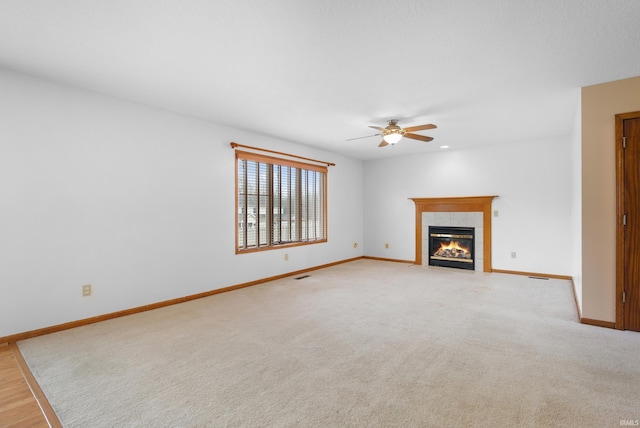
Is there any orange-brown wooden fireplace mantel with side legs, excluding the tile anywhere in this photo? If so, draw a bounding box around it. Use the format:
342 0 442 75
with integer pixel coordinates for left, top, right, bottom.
409 196 497 272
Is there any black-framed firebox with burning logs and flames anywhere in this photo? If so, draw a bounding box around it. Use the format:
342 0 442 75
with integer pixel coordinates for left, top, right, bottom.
429 226 475 270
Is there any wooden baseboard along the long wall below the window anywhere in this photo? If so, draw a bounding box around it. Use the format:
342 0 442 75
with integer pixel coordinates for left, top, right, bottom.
0 257 362 343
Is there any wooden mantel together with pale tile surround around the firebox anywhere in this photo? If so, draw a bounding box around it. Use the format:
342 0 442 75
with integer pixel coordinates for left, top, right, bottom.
410 196 497 272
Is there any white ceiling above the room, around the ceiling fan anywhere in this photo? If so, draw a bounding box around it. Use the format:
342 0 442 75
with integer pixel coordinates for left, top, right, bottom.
0 0 640 159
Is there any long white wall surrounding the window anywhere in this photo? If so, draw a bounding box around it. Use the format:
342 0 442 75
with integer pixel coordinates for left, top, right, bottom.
0 71 363 336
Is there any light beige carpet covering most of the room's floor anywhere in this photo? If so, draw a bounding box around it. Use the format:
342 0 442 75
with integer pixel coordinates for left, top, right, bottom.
18 260 640 427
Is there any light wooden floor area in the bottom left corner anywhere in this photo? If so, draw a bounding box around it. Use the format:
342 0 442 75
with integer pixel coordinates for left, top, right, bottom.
0 343 62 428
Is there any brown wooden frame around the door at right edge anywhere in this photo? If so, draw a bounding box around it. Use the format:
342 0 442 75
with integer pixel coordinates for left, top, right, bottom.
615 111 640 330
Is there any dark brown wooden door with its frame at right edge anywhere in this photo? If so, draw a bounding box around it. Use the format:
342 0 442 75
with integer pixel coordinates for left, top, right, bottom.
616 112 640 331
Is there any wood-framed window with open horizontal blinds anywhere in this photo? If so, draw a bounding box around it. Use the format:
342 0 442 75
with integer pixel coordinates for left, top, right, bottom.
236 150 327 253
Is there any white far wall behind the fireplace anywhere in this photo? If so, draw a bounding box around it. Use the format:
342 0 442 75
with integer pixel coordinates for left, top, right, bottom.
364 136 572 275
